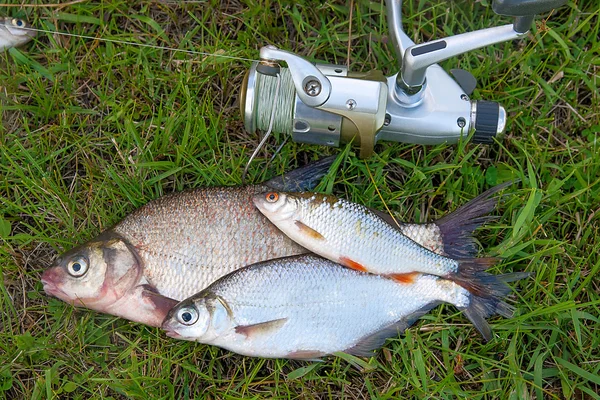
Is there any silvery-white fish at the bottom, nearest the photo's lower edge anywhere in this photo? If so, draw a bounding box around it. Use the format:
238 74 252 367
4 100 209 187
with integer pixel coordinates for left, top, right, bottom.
162 254 521 360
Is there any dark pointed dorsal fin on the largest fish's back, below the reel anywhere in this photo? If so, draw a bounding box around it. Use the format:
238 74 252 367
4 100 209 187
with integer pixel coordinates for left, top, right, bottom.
266 156 337 192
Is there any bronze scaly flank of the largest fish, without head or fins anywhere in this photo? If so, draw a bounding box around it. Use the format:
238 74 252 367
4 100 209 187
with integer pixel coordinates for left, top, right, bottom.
113 185 306 299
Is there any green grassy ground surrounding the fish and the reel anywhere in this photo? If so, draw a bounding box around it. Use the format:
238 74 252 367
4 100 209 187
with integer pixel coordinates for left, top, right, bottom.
0 0 600 399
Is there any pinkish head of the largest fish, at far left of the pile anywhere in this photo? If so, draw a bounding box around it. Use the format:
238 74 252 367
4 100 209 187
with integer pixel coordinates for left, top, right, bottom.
41 233 141 312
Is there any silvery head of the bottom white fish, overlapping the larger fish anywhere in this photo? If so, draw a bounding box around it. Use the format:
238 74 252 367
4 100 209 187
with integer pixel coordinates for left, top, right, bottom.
162 292 233 343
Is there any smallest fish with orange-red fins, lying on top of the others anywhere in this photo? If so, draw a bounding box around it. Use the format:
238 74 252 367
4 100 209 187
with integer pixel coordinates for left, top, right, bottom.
253 182 516 291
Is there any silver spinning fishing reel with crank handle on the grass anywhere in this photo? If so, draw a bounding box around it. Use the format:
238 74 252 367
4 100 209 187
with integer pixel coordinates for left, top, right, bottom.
240 0 566 158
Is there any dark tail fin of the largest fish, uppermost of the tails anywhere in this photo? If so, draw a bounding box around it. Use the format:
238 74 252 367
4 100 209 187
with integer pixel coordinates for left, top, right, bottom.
435 181 513 259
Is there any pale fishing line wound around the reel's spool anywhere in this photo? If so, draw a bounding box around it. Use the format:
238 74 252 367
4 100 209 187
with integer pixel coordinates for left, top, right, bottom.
254 68 296 135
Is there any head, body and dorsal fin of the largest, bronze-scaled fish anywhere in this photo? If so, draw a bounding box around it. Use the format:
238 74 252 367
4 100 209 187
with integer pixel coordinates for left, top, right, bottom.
41 157 335 327
